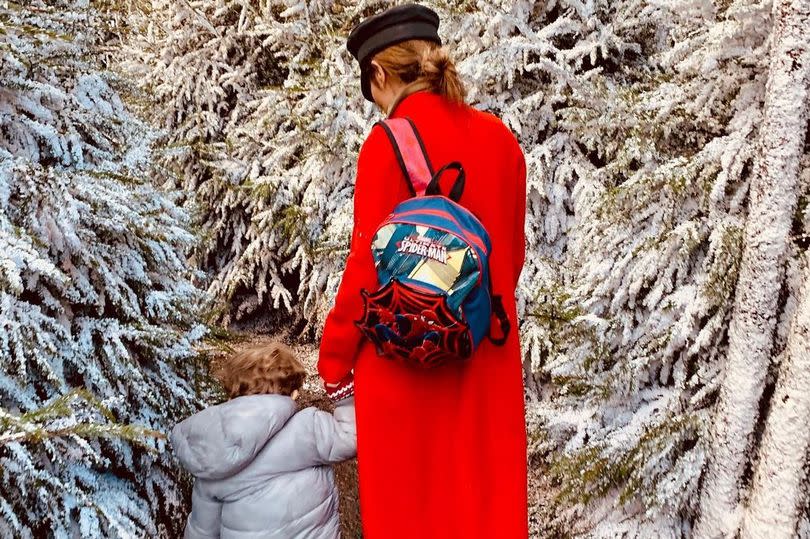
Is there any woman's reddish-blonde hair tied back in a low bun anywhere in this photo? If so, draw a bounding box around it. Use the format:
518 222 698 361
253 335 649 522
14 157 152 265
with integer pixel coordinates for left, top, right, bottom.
374 39 467 114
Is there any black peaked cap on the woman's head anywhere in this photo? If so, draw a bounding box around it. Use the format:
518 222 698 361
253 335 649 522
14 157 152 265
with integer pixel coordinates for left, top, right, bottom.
346 4 442 101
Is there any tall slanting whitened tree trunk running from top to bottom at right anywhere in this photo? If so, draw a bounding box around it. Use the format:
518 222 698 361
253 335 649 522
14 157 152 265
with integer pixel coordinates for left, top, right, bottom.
695 0 810 538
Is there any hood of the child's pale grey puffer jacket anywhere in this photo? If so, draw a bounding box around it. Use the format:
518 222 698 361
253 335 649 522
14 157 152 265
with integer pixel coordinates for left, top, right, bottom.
172 395 296 479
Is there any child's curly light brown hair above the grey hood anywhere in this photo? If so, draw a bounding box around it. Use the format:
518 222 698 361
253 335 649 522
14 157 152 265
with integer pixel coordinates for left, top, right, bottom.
214 342 307 399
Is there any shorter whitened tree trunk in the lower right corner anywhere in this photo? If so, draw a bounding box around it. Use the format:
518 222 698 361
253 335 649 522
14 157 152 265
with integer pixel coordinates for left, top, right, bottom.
742 256 810 539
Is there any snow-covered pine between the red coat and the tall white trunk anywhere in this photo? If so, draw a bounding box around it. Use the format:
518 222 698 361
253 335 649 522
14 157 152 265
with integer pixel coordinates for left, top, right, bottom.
516 2 806 537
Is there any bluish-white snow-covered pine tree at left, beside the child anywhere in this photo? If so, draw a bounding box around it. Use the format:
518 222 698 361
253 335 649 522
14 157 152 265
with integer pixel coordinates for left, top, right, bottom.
0 0 204 538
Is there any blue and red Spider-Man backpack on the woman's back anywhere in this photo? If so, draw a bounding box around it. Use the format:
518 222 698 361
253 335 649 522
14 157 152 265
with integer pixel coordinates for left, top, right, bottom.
355 118 510 367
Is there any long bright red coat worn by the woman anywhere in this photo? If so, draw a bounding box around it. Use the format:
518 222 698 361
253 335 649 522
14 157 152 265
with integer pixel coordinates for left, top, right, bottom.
318 91 528 539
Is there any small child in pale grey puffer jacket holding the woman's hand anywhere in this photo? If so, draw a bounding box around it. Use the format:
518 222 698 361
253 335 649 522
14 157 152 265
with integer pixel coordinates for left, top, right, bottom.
171 343 356 539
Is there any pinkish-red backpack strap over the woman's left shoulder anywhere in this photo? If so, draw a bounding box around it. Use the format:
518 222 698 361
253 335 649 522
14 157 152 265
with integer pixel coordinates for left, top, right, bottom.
377 118 433 196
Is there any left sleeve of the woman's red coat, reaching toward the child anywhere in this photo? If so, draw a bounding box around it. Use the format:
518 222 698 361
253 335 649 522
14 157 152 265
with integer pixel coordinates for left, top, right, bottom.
318 127 404 383
